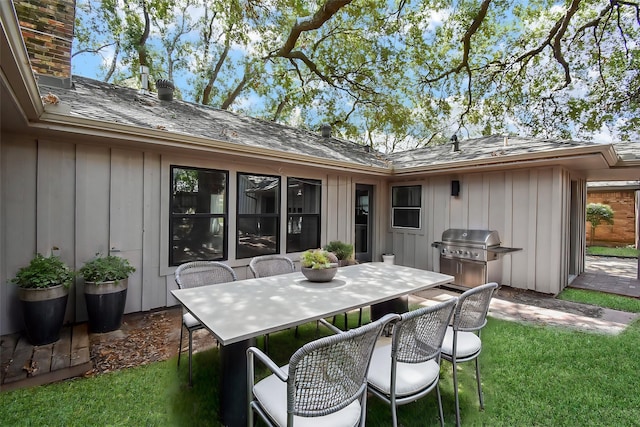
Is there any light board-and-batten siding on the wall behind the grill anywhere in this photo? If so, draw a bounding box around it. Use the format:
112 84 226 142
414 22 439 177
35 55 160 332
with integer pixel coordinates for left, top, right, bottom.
388 167 585 294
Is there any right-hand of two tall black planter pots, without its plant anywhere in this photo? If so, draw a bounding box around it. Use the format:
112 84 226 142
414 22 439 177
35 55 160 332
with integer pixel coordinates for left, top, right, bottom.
84 279 128 333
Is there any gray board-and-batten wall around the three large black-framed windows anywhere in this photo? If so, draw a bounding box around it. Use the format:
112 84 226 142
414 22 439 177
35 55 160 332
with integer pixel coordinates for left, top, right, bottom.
0 133 386 334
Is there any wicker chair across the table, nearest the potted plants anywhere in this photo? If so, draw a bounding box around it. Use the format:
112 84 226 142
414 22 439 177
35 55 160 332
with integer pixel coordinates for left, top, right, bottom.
174 261 238 386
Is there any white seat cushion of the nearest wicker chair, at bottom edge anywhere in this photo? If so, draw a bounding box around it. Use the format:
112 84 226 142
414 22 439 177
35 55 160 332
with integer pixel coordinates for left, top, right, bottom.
253 365 361 427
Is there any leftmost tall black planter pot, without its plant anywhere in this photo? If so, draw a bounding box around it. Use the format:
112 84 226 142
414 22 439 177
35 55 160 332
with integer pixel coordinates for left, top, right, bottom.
18 285 69 345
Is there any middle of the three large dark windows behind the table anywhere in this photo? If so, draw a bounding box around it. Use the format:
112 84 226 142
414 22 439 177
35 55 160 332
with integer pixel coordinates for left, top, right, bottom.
236 173 280 259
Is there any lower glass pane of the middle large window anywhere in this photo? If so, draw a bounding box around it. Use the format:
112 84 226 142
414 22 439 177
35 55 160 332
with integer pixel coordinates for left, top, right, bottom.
236 217 279 258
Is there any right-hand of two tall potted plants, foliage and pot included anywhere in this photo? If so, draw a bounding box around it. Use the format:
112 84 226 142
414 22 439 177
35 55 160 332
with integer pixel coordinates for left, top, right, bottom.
79 255 136 333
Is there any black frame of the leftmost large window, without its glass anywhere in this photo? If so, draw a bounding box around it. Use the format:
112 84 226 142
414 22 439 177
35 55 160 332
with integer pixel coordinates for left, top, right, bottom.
167 164 230 268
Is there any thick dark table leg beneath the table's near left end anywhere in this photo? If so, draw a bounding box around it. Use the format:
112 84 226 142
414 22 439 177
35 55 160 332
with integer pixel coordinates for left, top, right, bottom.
220 339 255 427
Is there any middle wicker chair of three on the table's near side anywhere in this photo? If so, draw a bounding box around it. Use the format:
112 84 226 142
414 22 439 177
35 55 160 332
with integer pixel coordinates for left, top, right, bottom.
367 298 458 427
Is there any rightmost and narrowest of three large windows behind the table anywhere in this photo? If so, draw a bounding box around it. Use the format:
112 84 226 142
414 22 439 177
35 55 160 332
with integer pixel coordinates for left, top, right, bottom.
287 178 322 253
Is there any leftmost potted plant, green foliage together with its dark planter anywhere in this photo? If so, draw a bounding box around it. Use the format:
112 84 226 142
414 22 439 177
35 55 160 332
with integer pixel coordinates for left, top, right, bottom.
11 253 74 345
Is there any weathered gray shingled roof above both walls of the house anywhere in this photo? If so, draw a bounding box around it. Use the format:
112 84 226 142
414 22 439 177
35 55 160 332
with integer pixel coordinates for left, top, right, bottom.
40 76 632 172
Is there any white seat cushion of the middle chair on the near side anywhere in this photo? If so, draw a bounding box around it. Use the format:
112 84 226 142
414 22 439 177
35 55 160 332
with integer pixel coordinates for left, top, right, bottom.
367 344 440 397
